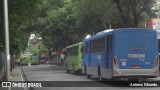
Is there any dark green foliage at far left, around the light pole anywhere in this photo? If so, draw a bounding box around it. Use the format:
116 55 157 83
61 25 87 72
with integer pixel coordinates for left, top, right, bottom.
0 0 40 54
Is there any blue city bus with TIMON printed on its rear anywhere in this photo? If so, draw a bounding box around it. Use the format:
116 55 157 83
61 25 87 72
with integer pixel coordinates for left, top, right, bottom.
82 28 159 80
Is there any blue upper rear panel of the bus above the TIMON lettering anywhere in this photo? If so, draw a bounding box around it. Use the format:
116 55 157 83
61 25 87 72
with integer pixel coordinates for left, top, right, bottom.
117 32 155 47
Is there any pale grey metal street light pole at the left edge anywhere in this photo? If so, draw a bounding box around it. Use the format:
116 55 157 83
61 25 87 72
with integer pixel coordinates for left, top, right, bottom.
3 0 10 81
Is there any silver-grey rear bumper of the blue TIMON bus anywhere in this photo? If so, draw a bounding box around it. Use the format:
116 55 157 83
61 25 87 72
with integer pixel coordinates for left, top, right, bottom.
113 66 159 78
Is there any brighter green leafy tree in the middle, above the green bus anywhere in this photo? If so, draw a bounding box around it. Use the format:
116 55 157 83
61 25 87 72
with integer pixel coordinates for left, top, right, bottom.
27 0 82 50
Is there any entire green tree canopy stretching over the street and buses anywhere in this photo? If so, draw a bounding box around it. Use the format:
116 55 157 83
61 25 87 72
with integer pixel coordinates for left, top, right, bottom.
0 0 159 53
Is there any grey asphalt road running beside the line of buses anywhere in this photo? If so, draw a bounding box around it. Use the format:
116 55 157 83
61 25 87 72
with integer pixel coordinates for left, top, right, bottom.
22 65 160 90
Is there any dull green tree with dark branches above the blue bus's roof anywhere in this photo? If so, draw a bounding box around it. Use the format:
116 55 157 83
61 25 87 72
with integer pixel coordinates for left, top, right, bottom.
75 0 156 33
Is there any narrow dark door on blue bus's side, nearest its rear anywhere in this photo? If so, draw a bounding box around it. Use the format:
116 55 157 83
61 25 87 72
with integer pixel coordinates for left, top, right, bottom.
106 35 113 68
